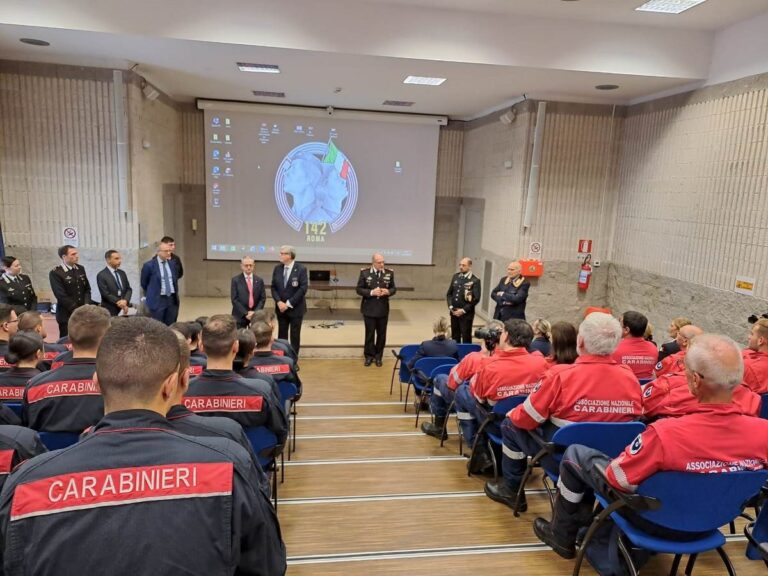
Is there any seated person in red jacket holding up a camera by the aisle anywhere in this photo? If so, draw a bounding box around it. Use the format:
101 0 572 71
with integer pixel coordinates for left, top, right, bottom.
421 320 504 440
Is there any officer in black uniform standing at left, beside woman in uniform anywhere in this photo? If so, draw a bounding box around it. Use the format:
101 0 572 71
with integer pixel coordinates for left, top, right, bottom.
48 244 91 336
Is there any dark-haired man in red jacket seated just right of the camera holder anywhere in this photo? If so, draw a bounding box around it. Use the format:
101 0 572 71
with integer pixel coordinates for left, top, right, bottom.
456 318 549 472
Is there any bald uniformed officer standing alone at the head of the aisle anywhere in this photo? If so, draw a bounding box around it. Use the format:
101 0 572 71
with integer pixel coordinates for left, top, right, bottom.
357 254 397 366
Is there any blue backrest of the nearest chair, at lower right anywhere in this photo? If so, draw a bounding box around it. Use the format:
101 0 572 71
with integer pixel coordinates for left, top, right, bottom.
637 470 768 532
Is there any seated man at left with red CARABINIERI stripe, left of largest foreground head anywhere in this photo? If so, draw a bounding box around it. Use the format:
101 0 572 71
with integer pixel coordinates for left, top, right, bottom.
22 304 111 434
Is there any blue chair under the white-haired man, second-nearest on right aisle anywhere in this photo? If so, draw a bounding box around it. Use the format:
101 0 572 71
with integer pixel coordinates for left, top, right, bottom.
514 422 645 516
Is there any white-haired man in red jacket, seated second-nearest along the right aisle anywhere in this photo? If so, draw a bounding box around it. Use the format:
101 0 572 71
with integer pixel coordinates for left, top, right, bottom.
485 312 642 512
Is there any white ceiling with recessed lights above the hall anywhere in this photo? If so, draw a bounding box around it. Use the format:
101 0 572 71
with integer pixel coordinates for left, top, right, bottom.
0 0 768 118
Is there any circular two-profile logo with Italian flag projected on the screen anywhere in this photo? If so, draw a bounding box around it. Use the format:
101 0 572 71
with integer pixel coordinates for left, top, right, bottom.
275 140 357 233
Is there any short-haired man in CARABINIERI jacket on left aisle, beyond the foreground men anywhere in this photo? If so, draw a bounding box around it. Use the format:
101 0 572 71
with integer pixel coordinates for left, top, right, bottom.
184 314 288 444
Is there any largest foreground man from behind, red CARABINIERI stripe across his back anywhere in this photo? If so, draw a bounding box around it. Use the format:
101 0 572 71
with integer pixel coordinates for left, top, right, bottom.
0 318 286 576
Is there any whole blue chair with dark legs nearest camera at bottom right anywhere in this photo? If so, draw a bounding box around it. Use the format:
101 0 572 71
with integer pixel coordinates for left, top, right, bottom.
573 470 768 576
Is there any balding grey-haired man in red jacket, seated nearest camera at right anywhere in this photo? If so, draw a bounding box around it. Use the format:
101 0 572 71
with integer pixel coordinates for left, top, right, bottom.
533 334 768 573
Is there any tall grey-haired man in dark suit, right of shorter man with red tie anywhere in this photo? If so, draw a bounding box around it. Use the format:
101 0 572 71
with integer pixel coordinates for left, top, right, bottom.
272 246 309 354
